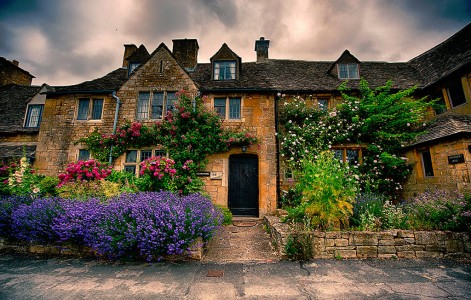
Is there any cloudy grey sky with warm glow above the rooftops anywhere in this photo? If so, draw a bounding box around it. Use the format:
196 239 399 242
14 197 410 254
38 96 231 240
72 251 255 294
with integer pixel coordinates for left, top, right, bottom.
0 0 471 85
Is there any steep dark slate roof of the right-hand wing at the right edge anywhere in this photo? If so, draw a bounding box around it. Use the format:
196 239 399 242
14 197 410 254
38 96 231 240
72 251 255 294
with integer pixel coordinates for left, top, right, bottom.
409 23 471 87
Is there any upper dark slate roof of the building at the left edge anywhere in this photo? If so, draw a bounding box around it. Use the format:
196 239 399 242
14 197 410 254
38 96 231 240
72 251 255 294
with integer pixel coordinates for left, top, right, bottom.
0 84 41 133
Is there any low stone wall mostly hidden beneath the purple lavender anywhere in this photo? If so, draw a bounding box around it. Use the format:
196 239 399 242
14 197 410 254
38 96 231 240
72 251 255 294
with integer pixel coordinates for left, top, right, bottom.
0 238 205 261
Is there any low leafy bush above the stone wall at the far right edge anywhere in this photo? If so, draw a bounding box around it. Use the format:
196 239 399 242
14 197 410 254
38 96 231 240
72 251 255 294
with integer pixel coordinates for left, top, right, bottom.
407 190 471 231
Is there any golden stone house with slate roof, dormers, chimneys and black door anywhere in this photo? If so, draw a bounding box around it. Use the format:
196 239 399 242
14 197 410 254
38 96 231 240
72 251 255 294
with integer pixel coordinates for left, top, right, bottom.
26 24 471 216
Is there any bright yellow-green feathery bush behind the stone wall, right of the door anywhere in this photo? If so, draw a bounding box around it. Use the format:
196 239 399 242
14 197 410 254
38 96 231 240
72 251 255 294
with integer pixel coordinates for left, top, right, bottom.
288 151 358 230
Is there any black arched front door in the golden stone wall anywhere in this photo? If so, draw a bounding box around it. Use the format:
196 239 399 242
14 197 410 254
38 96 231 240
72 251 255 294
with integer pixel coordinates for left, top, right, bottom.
229 155 258 216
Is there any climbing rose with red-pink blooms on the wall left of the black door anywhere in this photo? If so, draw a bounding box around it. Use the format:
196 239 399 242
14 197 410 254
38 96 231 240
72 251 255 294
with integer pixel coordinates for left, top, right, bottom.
79 91 257 194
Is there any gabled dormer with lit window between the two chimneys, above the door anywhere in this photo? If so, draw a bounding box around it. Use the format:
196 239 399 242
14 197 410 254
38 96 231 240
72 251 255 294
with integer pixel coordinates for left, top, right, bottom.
210 43 242 80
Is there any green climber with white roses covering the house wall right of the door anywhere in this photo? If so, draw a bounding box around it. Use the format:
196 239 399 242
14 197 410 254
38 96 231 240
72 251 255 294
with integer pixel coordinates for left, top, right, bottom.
280 80 433 196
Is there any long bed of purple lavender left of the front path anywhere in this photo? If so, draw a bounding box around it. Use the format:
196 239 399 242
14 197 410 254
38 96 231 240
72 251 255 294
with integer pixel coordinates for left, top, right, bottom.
0 192 222 261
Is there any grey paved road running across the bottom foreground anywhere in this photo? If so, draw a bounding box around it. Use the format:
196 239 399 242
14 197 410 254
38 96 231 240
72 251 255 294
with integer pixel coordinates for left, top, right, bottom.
0 254 471 300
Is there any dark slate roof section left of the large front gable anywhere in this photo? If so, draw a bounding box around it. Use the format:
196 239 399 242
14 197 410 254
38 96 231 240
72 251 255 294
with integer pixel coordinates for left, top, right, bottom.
47 68 127 95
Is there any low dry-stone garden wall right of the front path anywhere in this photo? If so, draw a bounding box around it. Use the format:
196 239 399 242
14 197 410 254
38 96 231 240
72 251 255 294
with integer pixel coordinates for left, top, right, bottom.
264 216 471 258
